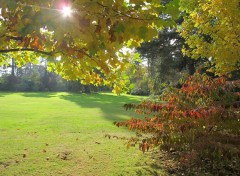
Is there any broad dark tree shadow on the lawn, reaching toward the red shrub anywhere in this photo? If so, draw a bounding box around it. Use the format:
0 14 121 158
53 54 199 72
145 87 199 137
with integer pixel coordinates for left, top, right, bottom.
60 93 142 122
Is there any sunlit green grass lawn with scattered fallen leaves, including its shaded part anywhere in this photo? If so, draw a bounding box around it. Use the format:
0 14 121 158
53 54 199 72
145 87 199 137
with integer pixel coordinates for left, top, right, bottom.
0 92 165 176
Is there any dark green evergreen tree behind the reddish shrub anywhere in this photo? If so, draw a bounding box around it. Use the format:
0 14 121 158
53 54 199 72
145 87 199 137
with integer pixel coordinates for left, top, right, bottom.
137 28 197 94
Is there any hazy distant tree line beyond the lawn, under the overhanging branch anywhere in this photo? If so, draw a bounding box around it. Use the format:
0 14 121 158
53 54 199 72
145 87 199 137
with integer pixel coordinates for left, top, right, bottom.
0 59 110 93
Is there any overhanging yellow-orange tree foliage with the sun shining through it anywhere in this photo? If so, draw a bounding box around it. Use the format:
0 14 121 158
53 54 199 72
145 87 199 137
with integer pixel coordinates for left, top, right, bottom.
0 0 178 93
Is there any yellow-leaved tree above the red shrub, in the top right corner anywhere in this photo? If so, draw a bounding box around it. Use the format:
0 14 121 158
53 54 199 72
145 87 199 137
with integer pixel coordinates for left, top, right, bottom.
179 0 240 75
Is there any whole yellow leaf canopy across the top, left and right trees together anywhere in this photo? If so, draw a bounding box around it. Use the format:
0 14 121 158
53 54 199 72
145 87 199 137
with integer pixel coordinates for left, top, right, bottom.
0 0 240 92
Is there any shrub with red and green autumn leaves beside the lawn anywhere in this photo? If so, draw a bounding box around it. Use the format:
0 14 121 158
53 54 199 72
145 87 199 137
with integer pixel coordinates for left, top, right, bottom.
116 74 240 152
